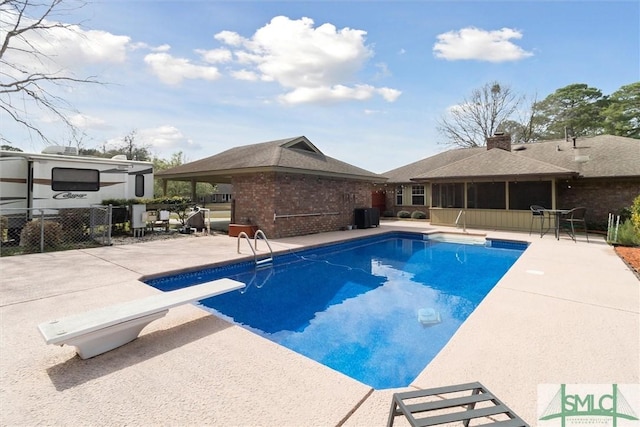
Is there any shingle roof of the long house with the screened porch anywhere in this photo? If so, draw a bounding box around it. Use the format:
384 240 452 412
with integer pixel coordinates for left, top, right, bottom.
383 135 640 182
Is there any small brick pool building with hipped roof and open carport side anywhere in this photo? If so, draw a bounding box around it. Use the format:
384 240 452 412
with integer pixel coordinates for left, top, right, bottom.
156 136 386 238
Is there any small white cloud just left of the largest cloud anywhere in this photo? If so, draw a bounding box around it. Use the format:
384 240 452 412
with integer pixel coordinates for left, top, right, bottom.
144 52 221 85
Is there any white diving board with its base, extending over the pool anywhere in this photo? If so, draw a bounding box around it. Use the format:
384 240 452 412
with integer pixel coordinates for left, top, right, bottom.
38 279 245 359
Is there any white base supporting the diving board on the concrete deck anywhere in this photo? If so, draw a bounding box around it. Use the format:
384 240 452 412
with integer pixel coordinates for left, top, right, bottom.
65 310 169 359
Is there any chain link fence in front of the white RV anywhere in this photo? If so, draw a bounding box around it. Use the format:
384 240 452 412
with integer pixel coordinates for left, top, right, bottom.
0 206 113 256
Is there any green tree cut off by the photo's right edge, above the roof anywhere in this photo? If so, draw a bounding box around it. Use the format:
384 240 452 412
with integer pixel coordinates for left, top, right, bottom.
602 82 640 139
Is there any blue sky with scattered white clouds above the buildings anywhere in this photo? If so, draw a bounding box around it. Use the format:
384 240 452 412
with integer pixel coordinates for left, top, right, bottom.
0 0 640 173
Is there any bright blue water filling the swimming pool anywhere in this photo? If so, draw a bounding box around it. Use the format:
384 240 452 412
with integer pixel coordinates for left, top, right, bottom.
147 233 526 389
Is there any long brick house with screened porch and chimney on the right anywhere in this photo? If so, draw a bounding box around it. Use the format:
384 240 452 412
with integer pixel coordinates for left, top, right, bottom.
382 135 640 230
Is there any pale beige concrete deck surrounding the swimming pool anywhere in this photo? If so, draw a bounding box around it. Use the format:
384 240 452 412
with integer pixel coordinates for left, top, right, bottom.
0 221 640 426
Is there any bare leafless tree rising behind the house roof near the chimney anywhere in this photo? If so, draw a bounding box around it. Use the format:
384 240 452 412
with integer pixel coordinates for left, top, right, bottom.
438 81 523 147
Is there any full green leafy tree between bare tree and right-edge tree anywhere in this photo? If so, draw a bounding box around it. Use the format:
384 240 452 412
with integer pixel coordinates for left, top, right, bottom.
535 83 608 139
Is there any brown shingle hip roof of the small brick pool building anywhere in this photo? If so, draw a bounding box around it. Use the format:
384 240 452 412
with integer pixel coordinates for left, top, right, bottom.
156 136 386 182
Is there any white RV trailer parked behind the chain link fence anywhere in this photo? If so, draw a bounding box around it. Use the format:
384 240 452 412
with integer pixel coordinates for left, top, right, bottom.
0 147 153 239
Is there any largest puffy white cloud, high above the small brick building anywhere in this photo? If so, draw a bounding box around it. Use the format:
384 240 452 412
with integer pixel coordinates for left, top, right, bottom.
215 16 400 104
